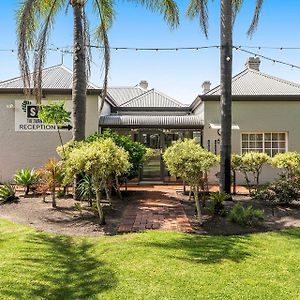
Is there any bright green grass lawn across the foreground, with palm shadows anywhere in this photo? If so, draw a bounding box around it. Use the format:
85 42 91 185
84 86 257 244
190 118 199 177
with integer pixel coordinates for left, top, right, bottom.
0 220 300 300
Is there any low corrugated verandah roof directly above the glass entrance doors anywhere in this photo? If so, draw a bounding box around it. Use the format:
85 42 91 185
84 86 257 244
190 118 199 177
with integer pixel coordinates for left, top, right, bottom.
99 115 204 128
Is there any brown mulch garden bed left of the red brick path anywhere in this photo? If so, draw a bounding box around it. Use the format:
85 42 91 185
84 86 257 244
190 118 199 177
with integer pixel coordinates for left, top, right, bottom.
0 196 126 236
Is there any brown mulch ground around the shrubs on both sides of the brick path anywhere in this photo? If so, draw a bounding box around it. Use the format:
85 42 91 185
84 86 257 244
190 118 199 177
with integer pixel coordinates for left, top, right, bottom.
0 186 300 236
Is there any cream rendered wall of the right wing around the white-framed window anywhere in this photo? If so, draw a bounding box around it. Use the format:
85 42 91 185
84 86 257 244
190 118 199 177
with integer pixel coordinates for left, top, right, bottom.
203 99 300 183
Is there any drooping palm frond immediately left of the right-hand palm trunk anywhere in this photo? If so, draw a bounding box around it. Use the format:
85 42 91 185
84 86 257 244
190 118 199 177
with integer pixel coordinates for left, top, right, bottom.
186 0 208 38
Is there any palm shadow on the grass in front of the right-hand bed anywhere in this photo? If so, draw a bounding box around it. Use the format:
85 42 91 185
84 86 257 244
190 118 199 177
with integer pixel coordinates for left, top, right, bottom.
140 234 252 264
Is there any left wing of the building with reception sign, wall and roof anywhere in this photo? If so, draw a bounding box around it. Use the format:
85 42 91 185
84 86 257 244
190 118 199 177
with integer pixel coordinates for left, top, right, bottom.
0 65 101 182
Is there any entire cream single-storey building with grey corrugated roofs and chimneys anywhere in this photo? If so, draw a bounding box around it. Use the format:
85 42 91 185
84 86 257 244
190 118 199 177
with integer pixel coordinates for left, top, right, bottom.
0 58 300 183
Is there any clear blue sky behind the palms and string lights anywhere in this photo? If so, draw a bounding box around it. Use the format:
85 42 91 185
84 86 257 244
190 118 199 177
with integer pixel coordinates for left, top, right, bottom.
0 0 300 103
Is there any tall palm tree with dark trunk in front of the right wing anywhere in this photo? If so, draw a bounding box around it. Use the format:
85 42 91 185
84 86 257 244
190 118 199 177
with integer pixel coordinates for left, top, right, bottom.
187 0 263 193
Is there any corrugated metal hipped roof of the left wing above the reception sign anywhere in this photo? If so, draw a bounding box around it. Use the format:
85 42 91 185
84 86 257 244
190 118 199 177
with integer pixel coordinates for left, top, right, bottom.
0 65 98 89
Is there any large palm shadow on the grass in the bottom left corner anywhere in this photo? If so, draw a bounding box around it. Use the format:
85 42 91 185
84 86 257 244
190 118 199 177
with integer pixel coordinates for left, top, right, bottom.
1 233 117 299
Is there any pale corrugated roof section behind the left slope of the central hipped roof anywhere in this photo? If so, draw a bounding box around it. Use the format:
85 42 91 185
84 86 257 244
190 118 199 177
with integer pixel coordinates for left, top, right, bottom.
108 86 147 106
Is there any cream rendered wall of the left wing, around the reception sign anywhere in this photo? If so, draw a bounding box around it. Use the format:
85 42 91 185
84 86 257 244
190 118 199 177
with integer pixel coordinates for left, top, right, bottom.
0 94 98 182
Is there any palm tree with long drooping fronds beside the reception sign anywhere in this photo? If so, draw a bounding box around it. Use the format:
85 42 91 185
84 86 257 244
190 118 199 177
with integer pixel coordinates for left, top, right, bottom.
17 0 179 141
